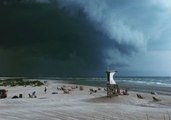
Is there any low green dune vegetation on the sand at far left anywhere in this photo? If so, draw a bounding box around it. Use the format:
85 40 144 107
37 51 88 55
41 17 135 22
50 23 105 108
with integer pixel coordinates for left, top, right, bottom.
0 79 44 87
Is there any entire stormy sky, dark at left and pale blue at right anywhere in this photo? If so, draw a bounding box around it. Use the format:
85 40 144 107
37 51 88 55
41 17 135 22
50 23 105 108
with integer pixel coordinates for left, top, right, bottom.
0 0 171 76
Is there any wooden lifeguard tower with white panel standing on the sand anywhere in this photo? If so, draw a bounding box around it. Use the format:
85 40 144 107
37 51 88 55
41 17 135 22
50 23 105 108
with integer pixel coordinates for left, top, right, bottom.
106 71 120 97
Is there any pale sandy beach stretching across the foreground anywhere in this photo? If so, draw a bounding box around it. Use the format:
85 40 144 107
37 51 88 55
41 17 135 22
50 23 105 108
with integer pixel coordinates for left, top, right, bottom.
0 81 171 120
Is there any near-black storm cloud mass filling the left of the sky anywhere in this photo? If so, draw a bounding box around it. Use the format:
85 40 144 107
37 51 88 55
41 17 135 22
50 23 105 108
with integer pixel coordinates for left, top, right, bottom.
0 0 111 76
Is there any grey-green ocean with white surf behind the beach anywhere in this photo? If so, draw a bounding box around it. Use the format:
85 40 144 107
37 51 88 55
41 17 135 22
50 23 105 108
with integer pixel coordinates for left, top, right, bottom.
0 76 171 95
